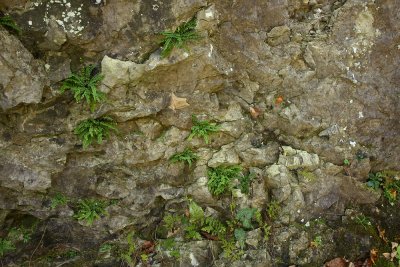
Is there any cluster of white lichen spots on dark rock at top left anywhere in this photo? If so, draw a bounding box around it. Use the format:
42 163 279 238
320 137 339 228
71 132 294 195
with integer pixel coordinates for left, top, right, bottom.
43 0 86 35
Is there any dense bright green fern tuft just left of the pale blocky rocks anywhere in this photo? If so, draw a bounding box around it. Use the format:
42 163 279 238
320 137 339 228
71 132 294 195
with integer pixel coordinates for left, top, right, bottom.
207 165 242 196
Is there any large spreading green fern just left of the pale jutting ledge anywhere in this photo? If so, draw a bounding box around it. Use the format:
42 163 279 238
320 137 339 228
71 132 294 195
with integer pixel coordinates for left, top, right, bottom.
60 65 105 112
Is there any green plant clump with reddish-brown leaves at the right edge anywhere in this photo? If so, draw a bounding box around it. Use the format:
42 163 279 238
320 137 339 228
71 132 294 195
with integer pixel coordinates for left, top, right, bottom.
367 170 400 205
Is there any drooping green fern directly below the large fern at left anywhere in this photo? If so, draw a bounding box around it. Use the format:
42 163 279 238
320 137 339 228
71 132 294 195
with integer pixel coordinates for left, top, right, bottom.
74 117 118 148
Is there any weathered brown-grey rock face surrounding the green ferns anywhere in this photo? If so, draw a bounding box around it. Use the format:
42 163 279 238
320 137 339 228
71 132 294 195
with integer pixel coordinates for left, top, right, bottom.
0 0 400 266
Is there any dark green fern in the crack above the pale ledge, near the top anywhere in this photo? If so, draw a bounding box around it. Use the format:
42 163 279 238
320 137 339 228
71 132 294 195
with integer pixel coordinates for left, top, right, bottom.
161 18 200 58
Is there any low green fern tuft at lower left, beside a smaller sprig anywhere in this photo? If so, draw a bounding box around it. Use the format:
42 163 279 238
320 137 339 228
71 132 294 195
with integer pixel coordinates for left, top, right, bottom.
75 199 108 226
